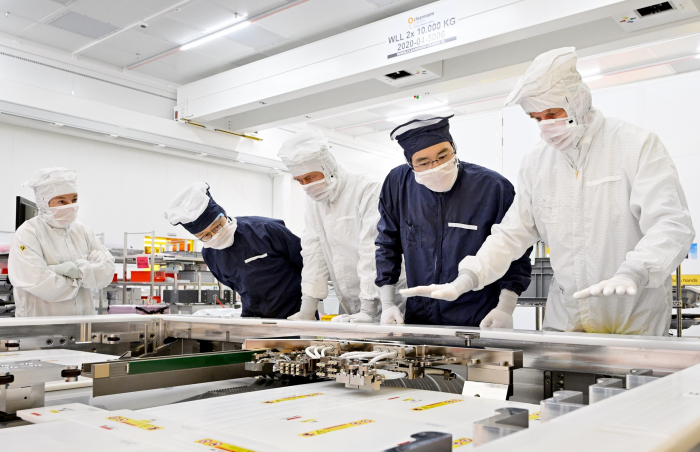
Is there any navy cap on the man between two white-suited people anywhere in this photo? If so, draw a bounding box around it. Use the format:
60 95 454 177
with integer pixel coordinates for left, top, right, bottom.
391 115 454 162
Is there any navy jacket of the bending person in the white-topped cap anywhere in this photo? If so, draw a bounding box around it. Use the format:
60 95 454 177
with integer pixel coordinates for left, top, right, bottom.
202 217 304 319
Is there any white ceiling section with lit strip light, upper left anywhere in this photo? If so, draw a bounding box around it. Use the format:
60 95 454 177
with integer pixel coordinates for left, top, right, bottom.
0 0 434 84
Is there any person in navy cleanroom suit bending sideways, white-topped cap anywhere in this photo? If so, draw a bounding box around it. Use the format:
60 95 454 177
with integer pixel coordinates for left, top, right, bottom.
166 182 303 319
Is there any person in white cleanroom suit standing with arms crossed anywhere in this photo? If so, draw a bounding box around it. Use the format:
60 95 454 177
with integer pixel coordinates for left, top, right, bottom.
8 168 115 317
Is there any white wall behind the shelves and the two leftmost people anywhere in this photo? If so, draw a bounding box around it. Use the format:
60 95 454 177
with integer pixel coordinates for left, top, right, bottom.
0 122 272 247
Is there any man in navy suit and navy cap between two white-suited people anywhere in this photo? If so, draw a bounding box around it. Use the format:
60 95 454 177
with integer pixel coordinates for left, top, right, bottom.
375 117 532 328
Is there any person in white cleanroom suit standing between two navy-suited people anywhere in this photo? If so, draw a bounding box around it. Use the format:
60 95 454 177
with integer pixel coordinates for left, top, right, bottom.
279 130 405 323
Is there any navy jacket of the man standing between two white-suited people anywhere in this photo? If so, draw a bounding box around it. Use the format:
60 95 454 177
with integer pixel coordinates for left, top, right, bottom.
376 162 532 326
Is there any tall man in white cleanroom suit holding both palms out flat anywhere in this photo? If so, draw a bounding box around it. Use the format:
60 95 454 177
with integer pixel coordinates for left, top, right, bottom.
400 47 695 336
